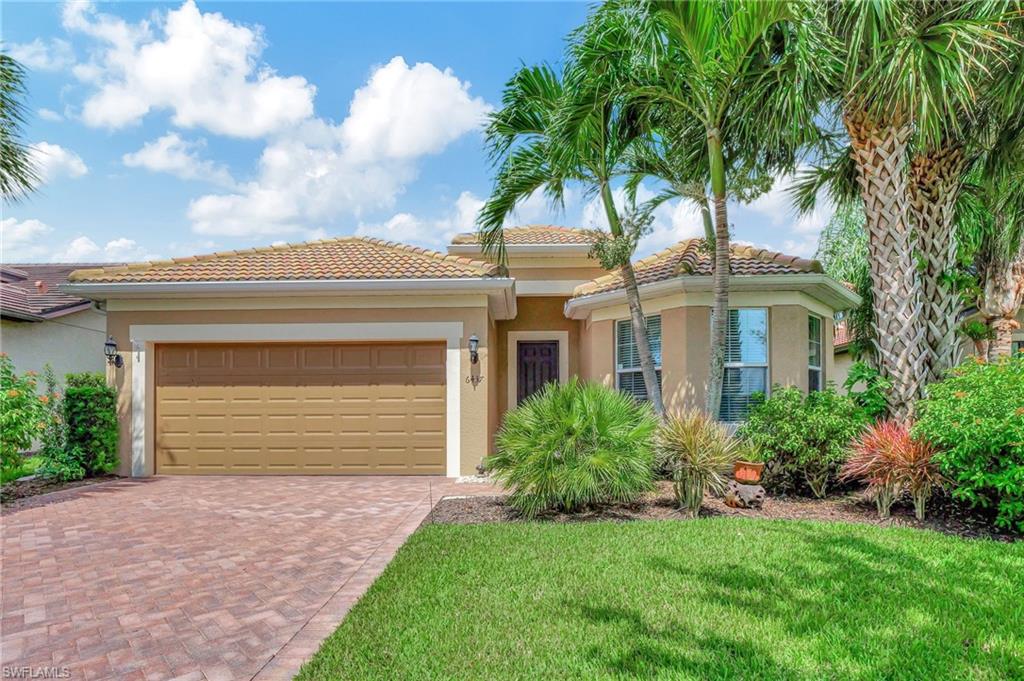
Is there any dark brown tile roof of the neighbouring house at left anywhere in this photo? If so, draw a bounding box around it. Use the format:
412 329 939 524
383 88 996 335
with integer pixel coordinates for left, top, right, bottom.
0 263 117 318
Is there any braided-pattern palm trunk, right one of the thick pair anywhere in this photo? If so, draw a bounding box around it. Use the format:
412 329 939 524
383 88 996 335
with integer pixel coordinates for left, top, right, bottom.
910 146 967 387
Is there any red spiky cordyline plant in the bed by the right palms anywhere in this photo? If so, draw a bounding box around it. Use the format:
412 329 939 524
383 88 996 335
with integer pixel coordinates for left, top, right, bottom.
840 421 944 520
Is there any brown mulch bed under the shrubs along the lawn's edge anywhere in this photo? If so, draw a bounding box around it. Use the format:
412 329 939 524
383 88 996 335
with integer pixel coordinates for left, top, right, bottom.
426 483 1024 542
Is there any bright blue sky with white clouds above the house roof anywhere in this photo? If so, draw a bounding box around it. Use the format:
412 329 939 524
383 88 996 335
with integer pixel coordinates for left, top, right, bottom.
0 0 830 263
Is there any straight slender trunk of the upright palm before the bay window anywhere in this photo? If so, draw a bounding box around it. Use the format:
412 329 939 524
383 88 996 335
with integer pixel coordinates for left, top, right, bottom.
705 128 731 419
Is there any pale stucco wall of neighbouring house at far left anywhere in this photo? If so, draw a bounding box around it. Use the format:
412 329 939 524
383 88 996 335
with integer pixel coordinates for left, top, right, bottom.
0 309 106 381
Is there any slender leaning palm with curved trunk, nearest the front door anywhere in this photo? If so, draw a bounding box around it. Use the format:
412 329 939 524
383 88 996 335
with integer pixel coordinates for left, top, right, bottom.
477 63 665 416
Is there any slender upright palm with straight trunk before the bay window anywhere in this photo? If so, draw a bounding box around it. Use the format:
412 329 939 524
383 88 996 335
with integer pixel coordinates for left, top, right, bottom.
579 0 831 415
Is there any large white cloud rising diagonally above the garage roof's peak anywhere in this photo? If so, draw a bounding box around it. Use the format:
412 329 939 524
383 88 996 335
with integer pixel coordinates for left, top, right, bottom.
188 57 488 236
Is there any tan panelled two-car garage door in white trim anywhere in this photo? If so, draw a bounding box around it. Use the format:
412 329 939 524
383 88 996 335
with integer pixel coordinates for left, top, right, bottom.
155 343 445 475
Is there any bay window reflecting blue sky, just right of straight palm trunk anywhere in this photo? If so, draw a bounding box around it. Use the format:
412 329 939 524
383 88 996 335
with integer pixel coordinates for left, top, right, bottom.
718 308 768 423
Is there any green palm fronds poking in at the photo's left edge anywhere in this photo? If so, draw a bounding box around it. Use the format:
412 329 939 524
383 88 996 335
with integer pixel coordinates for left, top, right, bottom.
0 52 39 201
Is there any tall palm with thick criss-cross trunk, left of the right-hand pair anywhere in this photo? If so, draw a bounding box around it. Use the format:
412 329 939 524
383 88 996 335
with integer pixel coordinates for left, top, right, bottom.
820 0 1006 419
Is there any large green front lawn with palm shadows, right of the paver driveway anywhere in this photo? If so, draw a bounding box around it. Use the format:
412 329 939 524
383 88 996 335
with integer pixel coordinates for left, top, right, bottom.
298 518 1024 679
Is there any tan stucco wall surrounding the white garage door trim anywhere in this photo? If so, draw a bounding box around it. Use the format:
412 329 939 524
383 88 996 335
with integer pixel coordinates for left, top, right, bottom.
100 301 494 475
